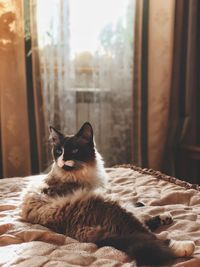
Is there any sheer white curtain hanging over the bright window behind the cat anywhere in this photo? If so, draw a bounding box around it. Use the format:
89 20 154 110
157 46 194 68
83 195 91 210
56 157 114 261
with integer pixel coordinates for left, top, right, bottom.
31 0 135 165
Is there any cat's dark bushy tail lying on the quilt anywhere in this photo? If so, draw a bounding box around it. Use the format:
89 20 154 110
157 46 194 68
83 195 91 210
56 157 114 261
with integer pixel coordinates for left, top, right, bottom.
96 233 176 266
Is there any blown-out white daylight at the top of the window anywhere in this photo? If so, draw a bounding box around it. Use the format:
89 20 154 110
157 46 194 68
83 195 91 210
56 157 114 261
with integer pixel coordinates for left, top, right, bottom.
37 0 130 56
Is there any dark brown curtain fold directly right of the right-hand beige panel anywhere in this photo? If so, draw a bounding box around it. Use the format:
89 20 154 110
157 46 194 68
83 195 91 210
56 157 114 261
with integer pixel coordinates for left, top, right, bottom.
163 1 190 175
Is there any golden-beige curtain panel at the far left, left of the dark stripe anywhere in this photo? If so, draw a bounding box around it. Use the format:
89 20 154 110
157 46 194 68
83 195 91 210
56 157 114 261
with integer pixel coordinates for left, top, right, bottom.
0 0 31 177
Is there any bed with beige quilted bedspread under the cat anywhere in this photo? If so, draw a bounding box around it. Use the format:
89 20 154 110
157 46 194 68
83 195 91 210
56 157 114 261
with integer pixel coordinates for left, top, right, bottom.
0 165 200 267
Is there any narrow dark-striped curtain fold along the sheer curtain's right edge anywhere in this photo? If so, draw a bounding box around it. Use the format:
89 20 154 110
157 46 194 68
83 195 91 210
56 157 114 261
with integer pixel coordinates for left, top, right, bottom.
132 0 149 167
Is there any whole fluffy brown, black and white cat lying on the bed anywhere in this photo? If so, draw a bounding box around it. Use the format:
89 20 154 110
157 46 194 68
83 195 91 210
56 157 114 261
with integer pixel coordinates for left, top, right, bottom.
21 122 194 266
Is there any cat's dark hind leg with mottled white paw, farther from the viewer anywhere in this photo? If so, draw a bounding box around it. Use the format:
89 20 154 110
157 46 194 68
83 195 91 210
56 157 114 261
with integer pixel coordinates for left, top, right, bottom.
144 212 173 232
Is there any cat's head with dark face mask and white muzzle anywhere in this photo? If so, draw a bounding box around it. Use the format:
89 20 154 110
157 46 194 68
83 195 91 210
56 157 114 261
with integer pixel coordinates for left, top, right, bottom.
49 122 95 171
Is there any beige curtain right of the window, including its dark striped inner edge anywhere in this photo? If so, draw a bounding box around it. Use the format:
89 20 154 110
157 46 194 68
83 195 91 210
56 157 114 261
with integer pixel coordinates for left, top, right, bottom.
133 0 175 169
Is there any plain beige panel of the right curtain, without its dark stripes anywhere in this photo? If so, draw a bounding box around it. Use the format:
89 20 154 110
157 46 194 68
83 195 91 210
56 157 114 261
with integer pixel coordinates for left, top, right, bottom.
147 0 176 170
